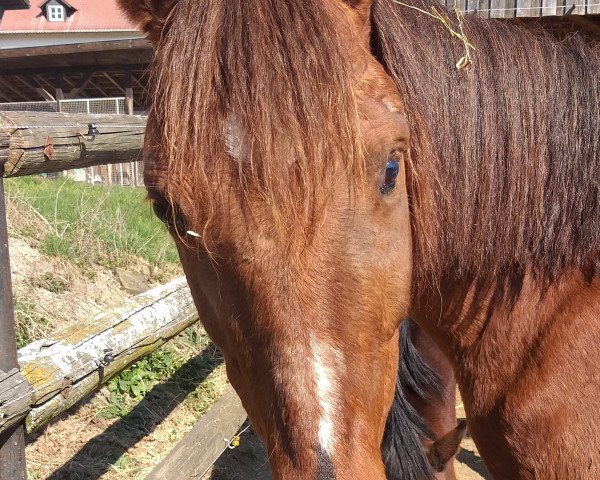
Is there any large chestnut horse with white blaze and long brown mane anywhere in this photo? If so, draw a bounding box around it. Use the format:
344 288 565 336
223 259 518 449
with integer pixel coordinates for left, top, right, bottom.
121 0 600 479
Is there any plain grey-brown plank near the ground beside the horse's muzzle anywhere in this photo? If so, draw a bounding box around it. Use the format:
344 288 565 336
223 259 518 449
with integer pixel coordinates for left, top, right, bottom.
146 387 246 480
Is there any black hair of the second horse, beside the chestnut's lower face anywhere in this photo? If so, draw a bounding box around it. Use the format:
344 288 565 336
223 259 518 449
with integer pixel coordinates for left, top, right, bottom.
381 319 442 480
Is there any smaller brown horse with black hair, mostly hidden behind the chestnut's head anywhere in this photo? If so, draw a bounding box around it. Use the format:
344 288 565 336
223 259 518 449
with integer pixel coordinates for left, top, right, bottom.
382 320 466 480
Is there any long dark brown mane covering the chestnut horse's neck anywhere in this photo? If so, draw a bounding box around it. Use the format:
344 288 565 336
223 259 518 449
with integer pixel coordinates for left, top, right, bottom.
373 0 600 282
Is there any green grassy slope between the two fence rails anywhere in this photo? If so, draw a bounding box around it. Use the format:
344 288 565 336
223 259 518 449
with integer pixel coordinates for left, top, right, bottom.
6 177 178 268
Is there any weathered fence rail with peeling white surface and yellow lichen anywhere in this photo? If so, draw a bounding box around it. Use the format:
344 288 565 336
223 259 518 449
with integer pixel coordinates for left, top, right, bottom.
0 278 198 433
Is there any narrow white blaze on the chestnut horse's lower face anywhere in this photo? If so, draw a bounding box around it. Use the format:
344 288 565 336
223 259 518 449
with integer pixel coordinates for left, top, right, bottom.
310 338 342 455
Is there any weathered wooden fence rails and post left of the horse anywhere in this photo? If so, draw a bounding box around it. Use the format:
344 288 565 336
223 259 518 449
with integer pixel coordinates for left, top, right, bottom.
0 112 246 480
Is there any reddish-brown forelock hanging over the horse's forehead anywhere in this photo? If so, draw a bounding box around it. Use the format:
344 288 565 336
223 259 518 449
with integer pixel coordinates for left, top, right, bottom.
152 0 362 240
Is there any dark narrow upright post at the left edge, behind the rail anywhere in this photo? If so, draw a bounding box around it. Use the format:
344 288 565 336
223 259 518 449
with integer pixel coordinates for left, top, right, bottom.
0 165 27 480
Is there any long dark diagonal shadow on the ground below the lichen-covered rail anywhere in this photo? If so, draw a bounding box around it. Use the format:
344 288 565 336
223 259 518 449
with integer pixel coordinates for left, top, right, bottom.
47 345 223 480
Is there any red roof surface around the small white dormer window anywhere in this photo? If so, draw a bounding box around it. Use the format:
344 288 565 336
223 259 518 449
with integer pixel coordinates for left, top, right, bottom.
0 0 137 34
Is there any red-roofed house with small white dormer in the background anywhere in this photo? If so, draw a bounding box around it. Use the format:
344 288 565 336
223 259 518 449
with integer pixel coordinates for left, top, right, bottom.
0 0 142 49
